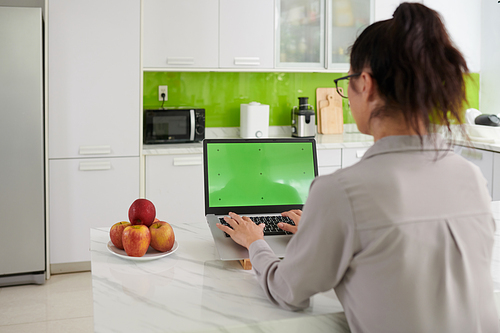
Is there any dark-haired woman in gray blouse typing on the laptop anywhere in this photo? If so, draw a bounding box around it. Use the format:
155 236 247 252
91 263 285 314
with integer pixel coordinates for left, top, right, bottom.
219 3 499 333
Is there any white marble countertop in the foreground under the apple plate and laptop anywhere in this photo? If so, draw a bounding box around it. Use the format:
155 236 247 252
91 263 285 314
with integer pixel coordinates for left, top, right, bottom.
90 201 500 333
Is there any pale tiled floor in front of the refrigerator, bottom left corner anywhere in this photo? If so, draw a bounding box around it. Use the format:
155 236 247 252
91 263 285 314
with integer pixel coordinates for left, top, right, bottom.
0 272 94 333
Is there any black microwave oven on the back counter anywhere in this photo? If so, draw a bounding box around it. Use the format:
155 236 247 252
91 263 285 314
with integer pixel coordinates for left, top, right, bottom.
143 107 205 144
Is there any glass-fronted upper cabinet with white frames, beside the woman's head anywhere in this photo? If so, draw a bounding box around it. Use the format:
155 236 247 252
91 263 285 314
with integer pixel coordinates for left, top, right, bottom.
276 0 373 72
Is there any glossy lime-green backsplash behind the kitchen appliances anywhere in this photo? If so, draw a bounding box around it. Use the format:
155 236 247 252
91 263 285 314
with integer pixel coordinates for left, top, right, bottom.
143 72 479 127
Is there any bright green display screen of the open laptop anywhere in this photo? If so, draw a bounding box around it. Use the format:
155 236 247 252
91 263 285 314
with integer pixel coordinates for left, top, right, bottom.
206 142 315 207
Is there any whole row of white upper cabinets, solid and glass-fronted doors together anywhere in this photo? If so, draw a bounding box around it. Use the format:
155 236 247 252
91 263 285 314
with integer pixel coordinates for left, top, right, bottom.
143 0 374 71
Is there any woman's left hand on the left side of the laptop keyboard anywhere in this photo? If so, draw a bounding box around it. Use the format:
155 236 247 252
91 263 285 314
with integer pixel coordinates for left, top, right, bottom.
217 212 265 249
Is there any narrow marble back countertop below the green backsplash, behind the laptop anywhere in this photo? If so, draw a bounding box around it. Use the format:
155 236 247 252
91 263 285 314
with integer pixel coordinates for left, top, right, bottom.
142 126 373 155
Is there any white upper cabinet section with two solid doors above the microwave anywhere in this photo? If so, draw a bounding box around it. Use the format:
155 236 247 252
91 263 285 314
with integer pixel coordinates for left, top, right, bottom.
143 0 274 69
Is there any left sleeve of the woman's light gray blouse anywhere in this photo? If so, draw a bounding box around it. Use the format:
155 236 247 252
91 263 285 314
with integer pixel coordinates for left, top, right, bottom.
249 176 355 310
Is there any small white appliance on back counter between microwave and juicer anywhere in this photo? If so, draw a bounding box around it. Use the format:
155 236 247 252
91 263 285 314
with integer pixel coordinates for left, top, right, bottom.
240 102 269 139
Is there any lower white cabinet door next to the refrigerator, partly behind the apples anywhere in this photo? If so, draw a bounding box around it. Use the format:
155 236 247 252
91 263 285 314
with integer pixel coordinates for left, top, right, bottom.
49 157 139 264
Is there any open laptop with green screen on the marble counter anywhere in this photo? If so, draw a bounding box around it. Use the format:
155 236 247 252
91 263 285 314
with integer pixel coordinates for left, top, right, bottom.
203 138 318 260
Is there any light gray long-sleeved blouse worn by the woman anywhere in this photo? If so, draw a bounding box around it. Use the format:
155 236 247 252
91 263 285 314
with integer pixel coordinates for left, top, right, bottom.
249 136 499 333
